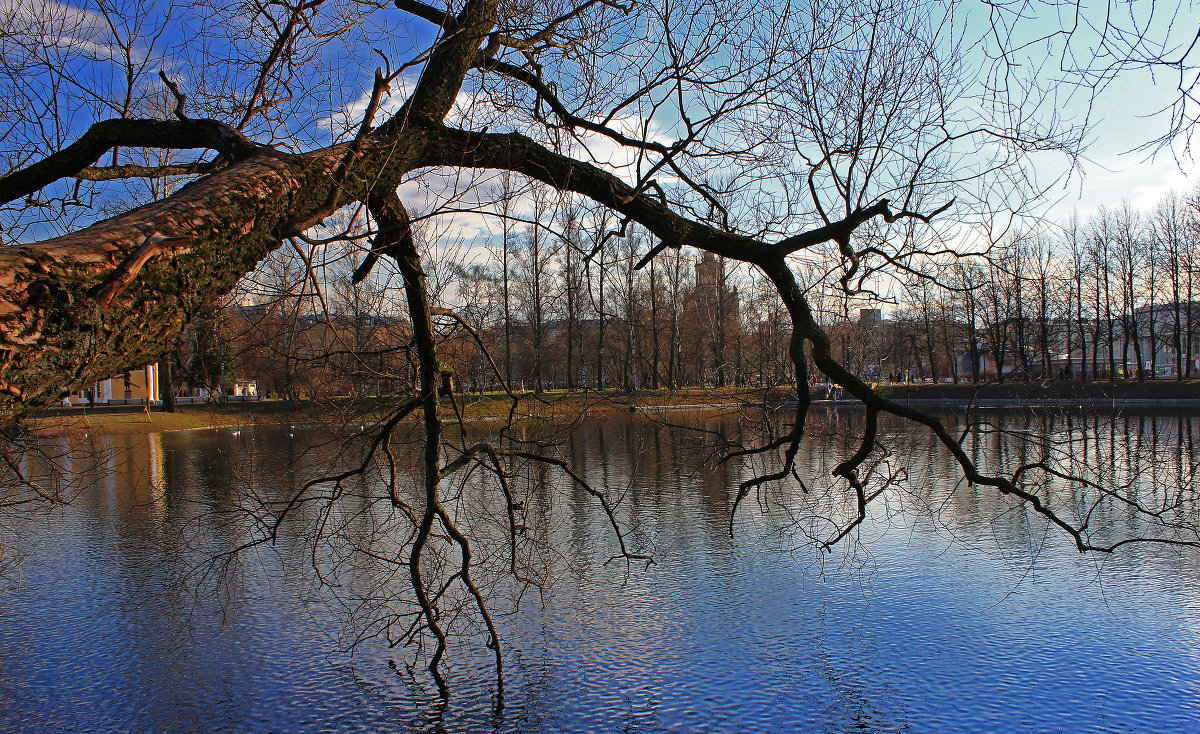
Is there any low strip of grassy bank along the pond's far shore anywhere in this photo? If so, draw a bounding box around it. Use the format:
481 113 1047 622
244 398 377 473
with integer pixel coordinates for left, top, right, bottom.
25 380 1200 434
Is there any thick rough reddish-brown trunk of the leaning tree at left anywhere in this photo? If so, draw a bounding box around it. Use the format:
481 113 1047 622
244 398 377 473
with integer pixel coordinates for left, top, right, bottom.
0 154 336 417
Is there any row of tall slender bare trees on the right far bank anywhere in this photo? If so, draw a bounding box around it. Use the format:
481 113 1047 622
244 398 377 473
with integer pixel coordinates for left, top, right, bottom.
866 193 1200 381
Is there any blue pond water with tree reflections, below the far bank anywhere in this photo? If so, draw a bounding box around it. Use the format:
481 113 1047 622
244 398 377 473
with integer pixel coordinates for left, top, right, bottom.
0 415 1200 732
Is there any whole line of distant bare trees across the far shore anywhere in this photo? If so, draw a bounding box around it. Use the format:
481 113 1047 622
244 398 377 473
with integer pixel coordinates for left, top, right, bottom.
170 183 1200 398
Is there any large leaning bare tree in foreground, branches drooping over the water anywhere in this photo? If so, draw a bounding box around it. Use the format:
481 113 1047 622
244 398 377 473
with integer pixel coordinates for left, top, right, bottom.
0 0 1196 687
